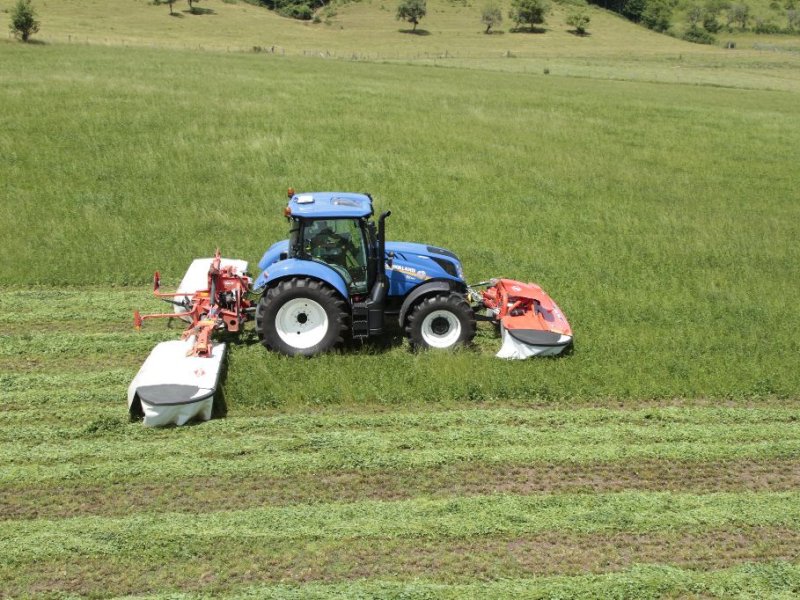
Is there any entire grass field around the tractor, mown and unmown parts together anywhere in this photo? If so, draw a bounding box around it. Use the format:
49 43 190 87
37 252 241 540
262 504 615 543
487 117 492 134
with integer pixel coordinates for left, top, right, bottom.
0 1 800 598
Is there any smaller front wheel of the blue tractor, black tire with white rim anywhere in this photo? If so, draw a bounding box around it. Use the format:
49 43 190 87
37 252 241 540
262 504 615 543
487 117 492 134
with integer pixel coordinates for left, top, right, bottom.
406 294 475 350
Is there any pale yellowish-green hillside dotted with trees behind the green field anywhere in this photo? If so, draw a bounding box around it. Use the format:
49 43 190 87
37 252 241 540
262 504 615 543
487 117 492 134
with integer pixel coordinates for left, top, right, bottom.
0 0 800 89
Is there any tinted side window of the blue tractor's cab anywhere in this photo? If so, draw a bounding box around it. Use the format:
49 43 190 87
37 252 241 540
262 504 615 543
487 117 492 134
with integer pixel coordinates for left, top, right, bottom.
303 219 367 294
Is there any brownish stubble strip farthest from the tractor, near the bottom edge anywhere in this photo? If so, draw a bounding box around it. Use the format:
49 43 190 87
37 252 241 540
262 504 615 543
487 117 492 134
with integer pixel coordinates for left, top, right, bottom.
0 527 800 597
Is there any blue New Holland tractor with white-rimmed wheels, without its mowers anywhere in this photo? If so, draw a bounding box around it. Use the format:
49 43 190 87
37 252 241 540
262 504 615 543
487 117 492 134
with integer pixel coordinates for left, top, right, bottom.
253 190 476 356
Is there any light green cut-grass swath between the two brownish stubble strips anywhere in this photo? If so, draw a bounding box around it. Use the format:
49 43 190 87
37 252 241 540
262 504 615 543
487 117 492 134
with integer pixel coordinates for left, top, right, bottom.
0 492 800 569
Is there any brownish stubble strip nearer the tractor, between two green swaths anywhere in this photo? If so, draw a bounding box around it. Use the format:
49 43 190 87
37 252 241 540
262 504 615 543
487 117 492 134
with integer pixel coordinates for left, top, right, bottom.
0 459 800 520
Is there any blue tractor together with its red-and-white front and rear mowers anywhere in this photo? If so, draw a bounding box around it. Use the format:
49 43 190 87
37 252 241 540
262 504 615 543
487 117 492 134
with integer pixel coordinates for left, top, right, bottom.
128 190 572 425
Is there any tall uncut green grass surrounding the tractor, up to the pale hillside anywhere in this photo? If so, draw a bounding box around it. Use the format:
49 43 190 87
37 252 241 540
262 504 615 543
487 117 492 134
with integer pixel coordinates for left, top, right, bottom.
0 45 800 407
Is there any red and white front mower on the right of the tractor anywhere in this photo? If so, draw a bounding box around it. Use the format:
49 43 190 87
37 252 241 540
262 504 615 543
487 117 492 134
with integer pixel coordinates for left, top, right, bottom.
483 279 572 359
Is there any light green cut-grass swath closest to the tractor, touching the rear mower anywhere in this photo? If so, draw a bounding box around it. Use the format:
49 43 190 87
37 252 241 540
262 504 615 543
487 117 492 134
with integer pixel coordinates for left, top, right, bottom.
0 398 800 484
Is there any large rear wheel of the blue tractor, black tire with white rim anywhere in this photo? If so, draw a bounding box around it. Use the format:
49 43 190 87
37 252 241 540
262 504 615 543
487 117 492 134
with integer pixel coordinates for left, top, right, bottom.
256 277 348 356
